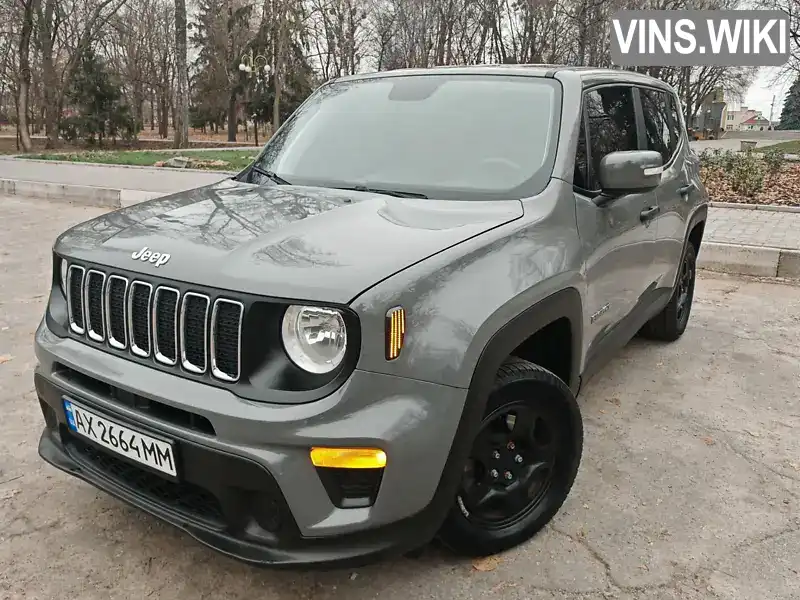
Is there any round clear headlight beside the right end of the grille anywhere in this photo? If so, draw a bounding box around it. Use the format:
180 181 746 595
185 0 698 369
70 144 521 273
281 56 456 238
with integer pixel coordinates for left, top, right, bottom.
281 305 347 374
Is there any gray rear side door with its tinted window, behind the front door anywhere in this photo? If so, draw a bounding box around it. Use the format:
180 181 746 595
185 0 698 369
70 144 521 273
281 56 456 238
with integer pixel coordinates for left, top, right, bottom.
639 87 693 287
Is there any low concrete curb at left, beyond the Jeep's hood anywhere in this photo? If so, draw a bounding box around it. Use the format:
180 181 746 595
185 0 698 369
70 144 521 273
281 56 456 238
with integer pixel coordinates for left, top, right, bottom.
0 179 167 208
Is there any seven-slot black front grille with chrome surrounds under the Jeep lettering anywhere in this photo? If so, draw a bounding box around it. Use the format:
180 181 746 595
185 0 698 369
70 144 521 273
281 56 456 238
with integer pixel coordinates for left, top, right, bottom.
66 265 244 383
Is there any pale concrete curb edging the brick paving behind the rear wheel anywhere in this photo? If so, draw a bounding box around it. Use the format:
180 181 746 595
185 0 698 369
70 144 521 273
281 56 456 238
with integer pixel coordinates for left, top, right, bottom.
697 242 800 279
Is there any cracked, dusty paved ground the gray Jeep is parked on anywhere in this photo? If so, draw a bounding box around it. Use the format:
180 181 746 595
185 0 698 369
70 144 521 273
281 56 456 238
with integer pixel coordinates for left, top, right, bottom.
0 197 800 600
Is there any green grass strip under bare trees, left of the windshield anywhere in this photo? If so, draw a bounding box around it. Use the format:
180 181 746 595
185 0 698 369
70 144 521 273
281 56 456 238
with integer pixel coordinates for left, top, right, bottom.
25 150 257 171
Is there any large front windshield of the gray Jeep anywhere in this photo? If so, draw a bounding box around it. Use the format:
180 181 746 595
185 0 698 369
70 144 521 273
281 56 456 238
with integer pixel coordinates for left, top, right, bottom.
256 75 561 200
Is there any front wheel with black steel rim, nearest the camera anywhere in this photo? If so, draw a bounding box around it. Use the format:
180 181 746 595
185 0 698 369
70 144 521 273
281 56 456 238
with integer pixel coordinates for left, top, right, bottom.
439 357 583 557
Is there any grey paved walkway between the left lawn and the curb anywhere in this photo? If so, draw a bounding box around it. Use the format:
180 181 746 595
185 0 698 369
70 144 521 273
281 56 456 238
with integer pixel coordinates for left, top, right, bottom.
0 158 228 194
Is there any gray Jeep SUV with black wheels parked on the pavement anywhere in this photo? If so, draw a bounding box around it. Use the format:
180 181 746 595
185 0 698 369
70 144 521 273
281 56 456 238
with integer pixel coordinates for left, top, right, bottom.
35 65 707 565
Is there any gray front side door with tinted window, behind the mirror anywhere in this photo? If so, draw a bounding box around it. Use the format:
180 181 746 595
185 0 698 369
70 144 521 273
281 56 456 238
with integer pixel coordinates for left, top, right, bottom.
575 85 658 356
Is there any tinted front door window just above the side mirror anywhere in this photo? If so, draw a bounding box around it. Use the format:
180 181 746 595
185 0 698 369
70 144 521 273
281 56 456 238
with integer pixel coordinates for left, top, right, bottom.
584 87 638 189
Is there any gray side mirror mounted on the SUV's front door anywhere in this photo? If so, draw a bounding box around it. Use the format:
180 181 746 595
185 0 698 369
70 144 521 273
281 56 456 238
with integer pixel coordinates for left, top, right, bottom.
598 150 664 204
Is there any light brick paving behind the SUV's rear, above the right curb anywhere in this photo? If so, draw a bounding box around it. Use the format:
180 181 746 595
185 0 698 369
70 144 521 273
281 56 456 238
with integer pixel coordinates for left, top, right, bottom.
704 206 800 250
